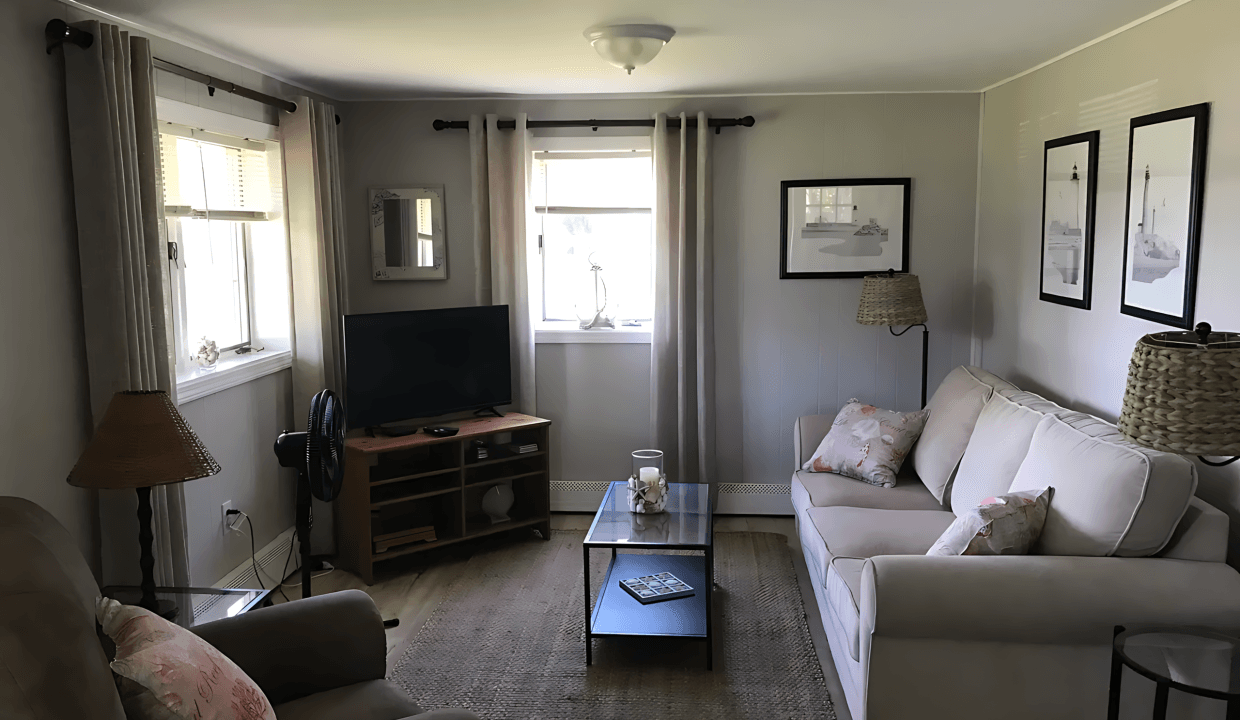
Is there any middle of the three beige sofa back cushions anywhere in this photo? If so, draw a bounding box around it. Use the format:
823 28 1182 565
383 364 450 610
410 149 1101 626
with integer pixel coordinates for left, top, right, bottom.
951 393 1043 517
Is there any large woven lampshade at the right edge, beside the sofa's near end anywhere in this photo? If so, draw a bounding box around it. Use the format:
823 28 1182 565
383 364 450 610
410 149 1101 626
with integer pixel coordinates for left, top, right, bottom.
1118 322 1240 467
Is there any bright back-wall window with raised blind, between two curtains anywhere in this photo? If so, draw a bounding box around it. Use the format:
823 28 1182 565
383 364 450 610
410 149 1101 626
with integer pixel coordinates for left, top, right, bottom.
532 138 653 325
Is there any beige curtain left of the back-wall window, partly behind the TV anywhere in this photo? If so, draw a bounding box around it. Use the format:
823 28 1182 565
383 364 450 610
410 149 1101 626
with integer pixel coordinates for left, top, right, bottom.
469 113 538 415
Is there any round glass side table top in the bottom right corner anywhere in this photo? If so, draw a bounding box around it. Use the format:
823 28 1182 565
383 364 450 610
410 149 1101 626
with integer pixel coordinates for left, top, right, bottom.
1115 628 1240 699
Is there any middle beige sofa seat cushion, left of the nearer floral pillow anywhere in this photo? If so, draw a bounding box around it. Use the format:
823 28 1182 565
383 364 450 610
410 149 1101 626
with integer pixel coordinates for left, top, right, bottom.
806 507 956 565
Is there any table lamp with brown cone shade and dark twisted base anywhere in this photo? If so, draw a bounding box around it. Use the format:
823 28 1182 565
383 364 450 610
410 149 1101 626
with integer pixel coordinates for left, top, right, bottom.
68 390 219 617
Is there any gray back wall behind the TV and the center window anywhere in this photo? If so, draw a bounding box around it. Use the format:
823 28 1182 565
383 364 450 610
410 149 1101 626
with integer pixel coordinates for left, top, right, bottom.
341 94 978 483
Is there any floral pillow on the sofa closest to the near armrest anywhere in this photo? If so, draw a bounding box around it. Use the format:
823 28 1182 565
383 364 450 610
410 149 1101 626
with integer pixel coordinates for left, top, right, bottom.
926 487 1054 555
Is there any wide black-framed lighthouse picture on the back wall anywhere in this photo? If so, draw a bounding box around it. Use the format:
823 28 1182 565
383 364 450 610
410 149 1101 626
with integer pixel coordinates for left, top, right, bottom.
779 177 913 279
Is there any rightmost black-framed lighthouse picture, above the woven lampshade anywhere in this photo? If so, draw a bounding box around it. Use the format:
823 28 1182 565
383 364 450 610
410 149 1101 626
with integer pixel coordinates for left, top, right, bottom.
1120 103 1210 330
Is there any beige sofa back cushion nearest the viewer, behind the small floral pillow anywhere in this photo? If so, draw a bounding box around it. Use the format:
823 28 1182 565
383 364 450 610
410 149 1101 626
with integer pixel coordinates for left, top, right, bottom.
1009 411 1197 558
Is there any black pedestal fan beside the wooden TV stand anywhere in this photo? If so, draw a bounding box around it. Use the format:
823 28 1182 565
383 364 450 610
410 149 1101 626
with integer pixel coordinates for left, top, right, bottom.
275 390 345 597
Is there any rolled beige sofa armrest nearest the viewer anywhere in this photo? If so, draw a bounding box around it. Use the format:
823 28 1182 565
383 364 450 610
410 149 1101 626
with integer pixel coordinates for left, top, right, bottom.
861 555 1240 644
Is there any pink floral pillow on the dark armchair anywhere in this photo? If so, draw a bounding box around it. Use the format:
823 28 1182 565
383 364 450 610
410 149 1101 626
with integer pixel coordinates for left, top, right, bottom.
94 597 275 720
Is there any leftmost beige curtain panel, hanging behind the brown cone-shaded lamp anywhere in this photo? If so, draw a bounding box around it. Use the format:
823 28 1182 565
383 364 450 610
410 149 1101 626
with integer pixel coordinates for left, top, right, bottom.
64 20 190 586
